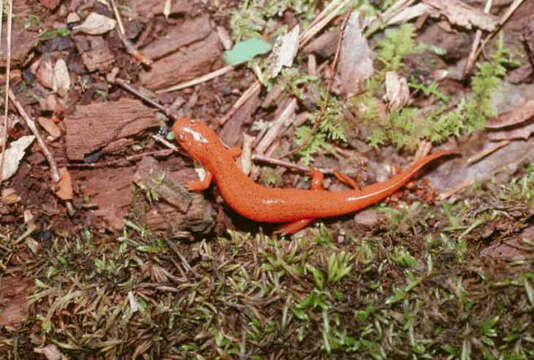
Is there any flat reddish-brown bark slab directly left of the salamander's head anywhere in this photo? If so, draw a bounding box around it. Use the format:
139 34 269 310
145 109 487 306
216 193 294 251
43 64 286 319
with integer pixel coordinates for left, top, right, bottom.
64 99 159 160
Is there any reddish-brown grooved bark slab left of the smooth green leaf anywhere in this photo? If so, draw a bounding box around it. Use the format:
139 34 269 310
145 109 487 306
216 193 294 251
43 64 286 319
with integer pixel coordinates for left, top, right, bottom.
140 32 221 89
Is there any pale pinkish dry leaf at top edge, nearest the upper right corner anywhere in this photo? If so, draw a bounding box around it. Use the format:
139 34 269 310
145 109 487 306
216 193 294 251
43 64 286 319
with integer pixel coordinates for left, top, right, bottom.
423 0 497 31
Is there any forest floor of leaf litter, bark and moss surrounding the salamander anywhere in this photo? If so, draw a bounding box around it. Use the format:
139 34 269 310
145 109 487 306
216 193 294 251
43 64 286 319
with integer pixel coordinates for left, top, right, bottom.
0 0 534 359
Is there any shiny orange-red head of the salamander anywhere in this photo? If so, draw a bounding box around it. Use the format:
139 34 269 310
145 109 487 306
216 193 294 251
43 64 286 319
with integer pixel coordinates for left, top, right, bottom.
172 118 220 160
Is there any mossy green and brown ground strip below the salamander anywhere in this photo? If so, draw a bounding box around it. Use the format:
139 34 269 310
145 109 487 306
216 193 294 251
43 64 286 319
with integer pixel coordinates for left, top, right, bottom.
0 167 534 359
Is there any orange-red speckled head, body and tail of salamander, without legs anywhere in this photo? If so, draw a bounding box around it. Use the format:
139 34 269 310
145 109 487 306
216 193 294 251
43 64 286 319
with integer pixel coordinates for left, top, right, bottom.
173 119 457 223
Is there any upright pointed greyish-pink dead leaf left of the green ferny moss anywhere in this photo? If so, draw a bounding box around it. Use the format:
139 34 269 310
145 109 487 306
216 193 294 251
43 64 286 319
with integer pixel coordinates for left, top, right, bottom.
337 11 374 97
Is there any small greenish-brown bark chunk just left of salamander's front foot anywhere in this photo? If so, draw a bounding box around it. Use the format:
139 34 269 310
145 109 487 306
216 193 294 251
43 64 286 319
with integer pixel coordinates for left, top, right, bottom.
134 156 192 213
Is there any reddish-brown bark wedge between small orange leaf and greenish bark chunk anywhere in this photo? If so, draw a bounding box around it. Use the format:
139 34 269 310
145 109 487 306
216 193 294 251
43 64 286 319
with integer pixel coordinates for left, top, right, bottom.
77 168 134 230
